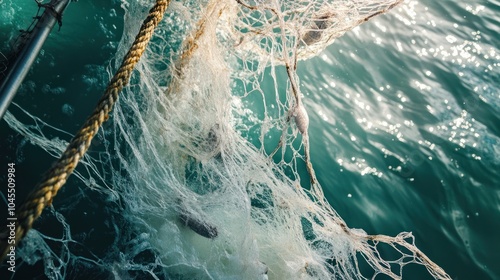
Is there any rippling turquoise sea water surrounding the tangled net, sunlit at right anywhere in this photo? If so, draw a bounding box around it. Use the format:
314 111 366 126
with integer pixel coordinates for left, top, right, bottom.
0 0 500 279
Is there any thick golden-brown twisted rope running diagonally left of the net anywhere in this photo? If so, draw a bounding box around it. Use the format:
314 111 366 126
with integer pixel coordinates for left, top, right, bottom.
0 0 170 263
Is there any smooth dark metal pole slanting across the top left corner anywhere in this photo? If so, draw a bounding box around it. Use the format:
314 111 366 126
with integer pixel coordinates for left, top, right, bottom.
0 0 69 119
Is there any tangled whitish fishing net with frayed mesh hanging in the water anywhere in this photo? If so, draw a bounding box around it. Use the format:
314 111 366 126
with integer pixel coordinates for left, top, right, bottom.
6 0 449 279
